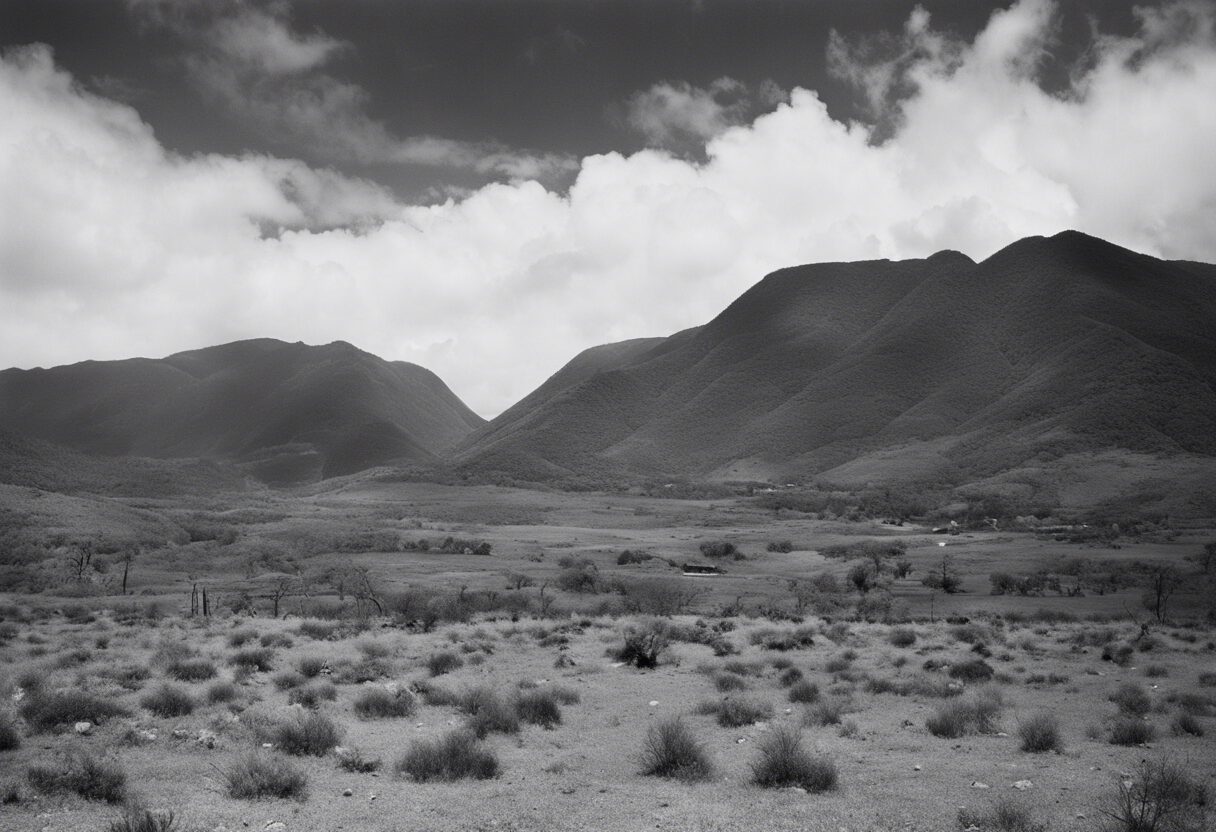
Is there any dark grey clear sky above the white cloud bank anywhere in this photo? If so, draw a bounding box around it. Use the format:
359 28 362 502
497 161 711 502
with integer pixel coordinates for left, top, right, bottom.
0 0 1135 198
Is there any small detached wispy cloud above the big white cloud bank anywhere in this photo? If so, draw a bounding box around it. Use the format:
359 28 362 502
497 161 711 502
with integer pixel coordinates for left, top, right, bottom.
625 78 787 150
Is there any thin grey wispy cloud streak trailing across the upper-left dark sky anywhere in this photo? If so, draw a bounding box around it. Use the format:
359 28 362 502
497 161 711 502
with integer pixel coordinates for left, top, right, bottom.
129 0 576 181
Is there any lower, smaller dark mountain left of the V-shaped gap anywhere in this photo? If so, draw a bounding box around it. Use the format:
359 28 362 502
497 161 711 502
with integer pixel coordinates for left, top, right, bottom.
0 338 484 484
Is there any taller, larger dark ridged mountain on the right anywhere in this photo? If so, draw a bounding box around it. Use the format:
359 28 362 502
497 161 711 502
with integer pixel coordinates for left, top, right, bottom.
451 231 1216 484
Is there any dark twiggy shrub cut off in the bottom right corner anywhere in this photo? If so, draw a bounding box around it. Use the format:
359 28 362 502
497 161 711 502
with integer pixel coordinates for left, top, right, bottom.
1102 759 1209 832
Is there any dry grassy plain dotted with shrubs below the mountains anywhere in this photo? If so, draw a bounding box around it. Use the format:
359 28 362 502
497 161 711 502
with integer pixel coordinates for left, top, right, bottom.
0 478 1216 832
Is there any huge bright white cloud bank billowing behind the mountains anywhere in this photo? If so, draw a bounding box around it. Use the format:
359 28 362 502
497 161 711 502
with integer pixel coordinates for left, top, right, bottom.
0 0 1216 415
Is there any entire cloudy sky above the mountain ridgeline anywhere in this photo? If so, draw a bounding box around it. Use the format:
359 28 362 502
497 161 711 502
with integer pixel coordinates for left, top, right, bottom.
0 0 1216 417
